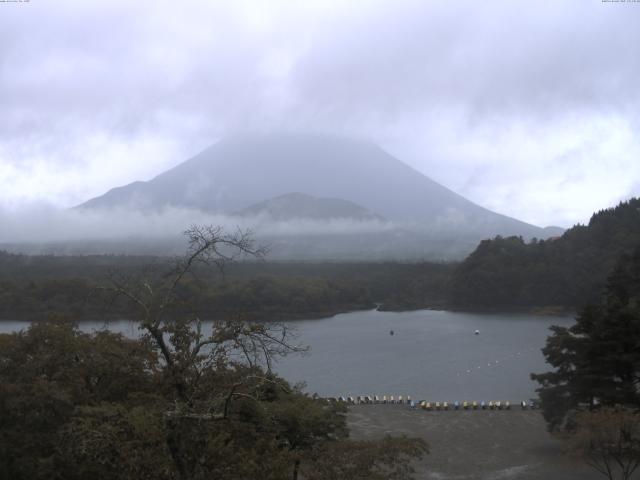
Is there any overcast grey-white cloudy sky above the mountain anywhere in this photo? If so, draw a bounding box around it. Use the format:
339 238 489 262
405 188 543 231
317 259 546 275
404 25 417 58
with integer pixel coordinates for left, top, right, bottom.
0 0 640 226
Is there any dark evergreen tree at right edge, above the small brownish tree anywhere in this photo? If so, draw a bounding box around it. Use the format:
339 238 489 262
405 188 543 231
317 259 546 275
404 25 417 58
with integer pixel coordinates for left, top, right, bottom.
532 249 640 430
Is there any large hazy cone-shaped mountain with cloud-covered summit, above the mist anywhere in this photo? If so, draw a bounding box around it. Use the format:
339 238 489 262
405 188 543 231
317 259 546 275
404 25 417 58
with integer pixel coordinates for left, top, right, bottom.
80 134 546 239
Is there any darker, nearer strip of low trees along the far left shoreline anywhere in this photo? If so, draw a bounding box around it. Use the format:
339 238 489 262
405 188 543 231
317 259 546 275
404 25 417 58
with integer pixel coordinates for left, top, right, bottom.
0 276 375 321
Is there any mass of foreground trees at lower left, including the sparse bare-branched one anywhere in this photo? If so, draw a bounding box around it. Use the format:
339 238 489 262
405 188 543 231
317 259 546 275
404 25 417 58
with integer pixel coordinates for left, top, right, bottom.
0 227 426 480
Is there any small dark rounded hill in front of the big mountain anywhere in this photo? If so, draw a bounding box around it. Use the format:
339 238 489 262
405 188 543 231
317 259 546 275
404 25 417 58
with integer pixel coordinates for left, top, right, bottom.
236 192 385 222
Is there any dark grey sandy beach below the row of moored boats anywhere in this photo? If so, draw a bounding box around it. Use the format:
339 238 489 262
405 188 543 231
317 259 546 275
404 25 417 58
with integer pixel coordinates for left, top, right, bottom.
348 405 604 480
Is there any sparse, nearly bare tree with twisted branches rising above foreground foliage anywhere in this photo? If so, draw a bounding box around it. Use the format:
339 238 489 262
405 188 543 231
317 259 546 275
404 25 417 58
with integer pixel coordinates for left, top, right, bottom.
102 225 304 479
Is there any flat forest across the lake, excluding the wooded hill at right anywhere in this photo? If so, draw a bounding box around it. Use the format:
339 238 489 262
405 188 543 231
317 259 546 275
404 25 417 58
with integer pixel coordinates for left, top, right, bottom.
0 252 452 321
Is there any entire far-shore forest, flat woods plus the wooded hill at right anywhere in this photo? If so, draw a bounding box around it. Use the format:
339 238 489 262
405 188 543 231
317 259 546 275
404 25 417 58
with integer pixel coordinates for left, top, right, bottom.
0 195 640 321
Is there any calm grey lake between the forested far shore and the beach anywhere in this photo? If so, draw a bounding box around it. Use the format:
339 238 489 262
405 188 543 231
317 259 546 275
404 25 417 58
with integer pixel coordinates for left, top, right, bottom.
0 310 574 402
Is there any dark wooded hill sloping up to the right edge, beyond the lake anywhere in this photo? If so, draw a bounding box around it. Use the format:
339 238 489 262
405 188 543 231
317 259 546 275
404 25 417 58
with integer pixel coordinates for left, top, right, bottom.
450 198 640 308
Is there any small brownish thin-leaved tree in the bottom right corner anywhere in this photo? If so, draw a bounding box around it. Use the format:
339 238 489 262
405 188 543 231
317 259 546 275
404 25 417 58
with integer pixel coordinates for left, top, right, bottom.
570 407 640 480
